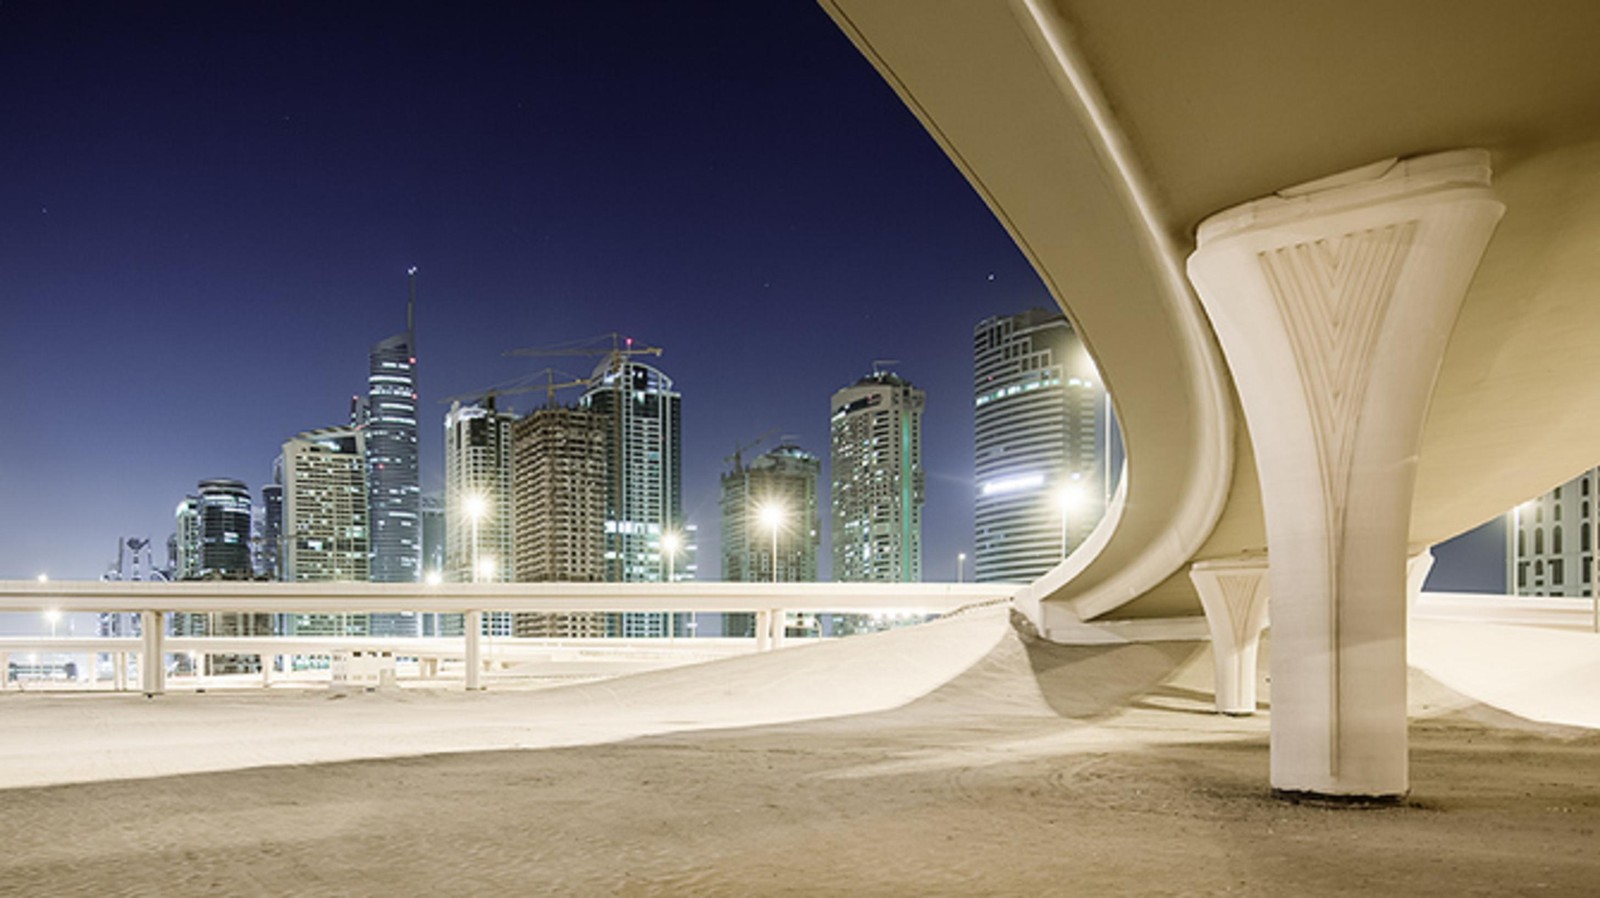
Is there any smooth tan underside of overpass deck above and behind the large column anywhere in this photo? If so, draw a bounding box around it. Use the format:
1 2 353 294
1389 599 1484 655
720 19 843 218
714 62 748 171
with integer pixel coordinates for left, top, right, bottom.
1036 0 1600 551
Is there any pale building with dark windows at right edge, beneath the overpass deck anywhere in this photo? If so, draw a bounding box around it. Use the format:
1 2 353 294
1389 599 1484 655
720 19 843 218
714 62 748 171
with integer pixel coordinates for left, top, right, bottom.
1506 469 1600 597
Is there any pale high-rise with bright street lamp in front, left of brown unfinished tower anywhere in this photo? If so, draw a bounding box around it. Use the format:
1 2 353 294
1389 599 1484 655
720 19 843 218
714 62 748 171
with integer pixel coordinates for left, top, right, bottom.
445 397 517 635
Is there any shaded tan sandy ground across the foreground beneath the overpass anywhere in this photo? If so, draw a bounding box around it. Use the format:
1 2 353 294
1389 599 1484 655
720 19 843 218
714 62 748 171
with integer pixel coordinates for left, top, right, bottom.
0 605 1600 895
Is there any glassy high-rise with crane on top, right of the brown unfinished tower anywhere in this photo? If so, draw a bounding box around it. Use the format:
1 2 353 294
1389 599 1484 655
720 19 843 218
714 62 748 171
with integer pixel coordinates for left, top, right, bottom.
579 355 683 637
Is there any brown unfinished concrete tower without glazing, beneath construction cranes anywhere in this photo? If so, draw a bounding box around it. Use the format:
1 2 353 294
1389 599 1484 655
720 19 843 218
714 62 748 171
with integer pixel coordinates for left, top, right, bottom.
512 407 606 639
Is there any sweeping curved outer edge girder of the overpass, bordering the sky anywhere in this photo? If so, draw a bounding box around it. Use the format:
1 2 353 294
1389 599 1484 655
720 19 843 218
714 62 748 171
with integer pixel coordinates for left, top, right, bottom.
824 0 1241 637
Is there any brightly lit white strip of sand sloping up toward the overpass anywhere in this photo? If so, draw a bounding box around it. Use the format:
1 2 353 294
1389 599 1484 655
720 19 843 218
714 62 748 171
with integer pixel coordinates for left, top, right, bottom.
0 603 1011 789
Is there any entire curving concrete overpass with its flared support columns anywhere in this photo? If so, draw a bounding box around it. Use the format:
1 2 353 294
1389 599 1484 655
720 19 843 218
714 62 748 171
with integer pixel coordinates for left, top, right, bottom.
822 0 1600 799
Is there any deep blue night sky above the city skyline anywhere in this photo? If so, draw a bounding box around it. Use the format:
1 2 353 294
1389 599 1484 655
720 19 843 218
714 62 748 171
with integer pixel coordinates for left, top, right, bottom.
0 0 1497 592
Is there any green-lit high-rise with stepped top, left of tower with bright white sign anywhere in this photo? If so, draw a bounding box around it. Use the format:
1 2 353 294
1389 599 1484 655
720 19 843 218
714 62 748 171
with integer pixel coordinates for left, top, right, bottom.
830 371 926 583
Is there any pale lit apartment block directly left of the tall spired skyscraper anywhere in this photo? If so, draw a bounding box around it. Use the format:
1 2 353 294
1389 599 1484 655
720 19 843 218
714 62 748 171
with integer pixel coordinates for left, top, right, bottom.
282 427 371 635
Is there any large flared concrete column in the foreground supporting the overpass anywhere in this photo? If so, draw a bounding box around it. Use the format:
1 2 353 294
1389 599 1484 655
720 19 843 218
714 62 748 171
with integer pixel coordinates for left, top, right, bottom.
1189 150 1504 799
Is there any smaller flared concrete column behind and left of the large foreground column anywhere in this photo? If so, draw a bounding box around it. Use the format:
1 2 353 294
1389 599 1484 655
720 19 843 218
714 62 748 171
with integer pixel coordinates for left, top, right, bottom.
1189 559 1267 717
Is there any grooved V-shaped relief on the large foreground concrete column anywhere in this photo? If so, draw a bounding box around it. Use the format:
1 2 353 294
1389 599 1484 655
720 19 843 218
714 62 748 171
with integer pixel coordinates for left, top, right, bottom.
1258 221 1418 539
